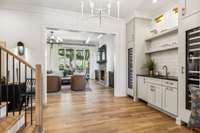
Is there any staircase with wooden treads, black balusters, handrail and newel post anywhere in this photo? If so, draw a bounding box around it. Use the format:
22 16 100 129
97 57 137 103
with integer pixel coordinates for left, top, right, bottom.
0 42 42 133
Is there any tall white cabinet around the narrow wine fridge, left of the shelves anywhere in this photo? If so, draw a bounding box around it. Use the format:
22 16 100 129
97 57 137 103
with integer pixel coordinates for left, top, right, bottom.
126 18 151 98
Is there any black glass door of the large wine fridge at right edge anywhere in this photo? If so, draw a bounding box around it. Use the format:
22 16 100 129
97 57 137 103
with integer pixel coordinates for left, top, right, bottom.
186 27 200 110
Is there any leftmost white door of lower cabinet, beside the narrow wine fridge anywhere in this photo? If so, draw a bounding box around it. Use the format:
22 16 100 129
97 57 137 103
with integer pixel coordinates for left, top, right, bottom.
137 76 147 102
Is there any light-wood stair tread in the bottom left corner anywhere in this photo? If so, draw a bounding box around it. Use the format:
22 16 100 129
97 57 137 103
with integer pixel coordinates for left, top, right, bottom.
0 112 24 133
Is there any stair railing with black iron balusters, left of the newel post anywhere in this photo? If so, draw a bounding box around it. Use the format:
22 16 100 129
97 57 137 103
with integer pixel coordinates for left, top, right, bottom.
0 45 35 126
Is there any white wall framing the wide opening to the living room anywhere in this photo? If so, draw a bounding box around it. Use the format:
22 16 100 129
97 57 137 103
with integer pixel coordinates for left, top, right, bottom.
0 2 126 104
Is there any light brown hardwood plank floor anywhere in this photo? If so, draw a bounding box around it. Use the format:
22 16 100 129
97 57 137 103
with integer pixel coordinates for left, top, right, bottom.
41 82 191 133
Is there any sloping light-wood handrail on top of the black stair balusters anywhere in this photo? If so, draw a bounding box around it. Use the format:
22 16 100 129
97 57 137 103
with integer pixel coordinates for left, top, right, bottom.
0 45 35 70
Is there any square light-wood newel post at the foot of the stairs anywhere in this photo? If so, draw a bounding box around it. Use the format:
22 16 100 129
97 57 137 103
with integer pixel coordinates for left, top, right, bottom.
35 65 43 133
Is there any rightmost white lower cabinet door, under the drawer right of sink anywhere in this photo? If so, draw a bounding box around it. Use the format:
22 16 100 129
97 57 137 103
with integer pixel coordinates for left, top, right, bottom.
163 86 178 115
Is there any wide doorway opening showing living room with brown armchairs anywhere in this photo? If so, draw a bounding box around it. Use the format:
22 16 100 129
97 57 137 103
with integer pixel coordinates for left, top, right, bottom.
46 28 116 94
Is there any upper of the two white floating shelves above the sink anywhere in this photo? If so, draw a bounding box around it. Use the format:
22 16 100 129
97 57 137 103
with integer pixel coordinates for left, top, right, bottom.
146 27 178 41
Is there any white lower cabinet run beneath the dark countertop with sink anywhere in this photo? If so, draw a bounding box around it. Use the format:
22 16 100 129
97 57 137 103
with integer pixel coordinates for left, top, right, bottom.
137 77 178 116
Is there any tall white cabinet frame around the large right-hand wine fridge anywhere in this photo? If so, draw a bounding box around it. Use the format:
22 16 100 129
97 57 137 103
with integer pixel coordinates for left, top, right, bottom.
178 0 200 123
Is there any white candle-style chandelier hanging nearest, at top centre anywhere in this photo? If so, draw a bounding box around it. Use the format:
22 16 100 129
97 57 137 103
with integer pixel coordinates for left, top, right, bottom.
81 0 120 26
